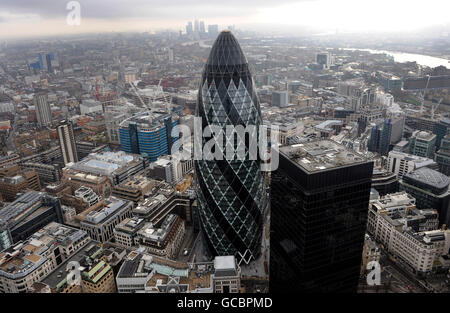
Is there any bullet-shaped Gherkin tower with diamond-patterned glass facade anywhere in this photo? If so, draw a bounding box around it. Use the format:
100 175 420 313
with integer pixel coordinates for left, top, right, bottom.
195 31 265 260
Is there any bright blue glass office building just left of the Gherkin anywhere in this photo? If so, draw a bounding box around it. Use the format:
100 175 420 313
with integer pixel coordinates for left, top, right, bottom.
119 112 179 162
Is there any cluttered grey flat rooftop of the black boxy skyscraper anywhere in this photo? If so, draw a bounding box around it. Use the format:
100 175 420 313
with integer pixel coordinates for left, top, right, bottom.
280 140 368 172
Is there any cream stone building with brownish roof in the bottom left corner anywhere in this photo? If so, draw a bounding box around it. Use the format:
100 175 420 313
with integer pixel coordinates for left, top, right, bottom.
0 222 89 293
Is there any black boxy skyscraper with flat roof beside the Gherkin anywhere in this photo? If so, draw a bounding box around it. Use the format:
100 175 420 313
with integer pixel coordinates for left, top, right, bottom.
269 140 373 293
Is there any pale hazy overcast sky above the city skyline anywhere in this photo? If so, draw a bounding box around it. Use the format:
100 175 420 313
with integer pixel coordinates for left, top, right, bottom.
0 0 450 38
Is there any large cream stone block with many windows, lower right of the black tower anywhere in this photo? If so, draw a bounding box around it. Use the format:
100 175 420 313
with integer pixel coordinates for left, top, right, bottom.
367 192 450 275
